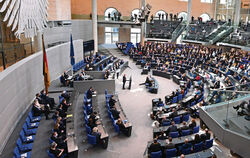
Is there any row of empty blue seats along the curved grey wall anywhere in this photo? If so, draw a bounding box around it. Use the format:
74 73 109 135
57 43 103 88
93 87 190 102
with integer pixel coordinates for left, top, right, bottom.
13 110 41 158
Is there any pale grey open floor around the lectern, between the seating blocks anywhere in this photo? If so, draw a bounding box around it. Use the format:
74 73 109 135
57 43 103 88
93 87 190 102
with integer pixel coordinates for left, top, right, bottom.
106 46 178 158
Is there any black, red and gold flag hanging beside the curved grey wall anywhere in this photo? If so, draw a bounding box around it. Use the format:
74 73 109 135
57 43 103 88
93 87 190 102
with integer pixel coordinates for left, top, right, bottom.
42 35 50 94
